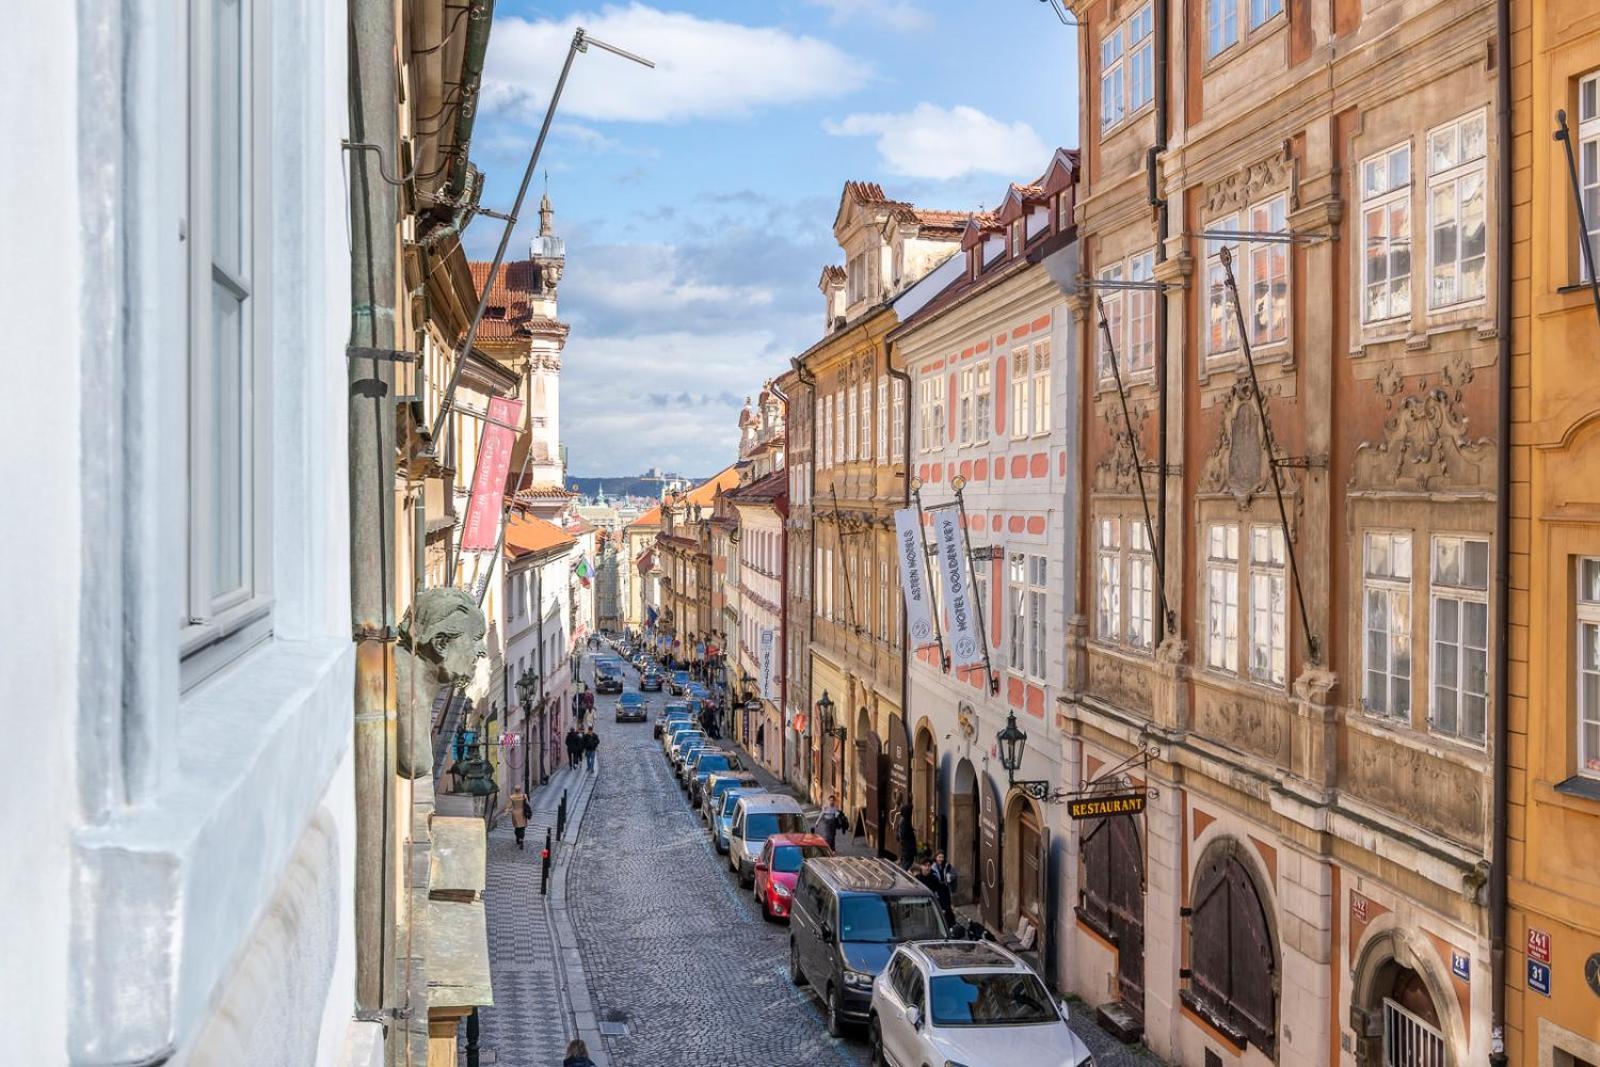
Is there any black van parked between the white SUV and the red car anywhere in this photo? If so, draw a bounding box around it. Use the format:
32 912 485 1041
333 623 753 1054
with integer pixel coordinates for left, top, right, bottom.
789 856 947 1037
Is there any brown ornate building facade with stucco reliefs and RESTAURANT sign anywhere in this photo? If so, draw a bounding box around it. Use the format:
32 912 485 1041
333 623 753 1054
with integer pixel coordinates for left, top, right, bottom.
1058 0 1509 1065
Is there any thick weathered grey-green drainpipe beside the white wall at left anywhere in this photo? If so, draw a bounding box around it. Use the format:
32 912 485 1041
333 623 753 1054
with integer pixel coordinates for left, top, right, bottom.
346 0 405 1017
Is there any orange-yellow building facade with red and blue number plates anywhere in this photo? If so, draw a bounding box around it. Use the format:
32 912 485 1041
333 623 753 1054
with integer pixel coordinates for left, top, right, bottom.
1506 0 1600 1067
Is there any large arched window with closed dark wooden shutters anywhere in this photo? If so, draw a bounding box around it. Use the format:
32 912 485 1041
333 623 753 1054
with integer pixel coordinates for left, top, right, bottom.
1182 841 1278 1056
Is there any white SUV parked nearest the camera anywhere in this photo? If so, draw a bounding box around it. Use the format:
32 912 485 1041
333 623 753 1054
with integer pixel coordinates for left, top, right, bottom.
867 941 1094 1067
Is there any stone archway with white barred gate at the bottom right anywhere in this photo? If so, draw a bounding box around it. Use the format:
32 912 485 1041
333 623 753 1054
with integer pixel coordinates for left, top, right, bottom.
1350 926 1466 1067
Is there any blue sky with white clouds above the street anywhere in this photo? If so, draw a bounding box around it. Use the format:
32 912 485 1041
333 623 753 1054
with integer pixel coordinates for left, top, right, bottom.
467 0 1077 475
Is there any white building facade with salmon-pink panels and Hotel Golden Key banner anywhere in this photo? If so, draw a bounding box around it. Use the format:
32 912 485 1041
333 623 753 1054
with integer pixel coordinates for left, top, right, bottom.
890 150 1080 979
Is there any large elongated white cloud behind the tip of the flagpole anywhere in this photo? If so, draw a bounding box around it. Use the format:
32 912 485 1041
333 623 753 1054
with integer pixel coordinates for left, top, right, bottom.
483 3 870 122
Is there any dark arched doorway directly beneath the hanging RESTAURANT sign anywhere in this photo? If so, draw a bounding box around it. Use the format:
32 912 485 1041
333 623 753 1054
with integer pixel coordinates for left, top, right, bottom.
1078 816 1144 1024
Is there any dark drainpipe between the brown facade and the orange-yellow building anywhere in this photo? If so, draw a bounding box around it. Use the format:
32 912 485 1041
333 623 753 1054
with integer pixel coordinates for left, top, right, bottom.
1490 0 1512 1067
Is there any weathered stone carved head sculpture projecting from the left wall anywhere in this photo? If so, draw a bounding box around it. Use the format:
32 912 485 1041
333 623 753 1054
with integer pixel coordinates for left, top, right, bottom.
395 587 490 779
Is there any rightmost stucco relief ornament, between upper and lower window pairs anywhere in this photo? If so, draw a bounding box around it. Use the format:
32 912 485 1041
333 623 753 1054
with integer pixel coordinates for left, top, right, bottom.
1350 355 1494 493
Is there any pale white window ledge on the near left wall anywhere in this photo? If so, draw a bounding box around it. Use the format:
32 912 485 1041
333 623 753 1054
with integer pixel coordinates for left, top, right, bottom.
70 637 355 1064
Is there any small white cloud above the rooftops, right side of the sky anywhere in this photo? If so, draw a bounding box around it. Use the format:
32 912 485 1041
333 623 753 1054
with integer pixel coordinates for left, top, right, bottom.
822 104 1050 181
